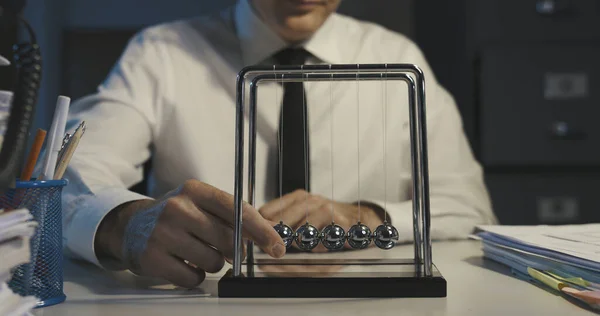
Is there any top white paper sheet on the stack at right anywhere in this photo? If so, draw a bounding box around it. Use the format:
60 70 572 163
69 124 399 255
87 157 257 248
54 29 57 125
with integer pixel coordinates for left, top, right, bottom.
478 224 600 263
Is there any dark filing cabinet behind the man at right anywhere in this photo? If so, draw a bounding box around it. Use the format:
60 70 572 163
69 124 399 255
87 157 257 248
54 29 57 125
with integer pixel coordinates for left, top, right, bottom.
415 0 600 225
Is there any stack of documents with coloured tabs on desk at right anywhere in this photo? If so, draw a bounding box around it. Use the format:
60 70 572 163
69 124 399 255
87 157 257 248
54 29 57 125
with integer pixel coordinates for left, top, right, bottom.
476 224 600 309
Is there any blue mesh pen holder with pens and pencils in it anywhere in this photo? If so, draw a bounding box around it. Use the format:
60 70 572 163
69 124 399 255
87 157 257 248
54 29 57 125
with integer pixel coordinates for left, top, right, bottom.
0 180 67 307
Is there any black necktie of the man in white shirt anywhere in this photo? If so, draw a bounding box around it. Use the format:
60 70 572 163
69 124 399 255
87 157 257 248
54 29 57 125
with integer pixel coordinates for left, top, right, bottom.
273 48 310 195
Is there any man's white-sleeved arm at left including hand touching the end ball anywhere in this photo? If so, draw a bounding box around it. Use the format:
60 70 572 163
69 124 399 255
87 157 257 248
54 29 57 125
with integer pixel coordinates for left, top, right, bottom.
63 29 285 287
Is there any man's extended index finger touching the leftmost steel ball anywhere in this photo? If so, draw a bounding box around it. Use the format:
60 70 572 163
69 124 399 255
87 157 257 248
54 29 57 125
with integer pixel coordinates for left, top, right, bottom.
182 181 285 258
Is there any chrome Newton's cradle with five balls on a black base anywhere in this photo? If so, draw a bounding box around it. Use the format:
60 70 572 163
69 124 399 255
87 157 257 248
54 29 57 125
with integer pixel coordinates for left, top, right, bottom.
219 64 446 297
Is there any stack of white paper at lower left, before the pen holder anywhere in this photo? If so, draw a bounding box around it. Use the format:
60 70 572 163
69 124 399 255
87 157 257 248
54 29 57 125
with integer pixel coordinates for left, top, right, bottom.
0 209 37 316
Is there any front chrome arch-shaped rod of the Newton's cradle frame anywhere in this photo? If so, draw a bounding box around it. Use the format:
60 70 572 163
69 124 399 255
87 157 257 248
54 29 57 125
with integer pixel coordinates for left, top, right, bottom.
233 64 432 276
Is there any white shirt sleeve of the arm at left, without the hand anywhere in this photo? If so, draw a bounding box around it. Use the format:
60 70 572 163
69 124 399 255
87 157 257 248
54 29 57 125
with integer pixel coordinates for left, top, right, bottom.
63 29 165 264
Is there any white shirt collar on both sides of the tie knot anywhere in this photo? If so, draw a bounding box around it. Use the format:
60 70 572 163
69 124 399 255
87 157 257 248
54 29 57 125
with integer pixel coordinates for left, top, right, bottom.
235 0 343 65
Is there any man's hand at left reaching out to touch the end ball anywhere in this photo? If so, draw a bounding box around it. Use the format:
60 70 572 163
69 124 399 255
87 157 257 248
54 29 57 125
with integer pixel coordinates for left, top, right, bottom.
95 180 285 288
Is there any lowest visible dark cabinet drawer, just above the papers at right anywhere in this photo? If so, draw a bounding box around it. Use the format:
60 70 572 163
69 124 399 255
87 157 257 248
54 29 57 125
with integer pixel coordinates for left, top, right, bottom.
486 174 600 225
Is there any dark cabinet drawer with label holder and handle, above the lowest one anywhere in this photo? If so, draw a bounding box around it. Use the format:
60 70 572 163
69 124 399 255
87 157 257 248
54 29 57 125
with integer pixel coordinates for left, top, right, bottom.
479 47 600 166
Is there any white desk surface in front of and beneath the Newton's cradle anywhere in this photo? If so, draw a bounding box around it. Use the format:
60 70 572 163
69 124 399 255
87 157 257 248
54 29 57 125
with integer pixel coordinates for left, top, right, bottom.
34 241 594 316
